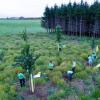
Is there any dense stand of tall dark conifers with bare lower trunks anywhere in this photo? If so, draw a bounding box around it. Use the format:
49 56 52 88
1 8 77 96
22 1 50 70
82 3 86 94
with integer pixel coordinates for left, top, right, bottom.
42 0 100 37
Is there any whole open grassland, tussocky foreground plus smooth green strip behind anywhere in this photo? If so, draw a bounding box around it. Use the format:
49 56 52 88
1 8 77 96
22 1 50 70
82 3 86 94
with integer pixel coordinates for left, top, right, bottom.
0 20 100 100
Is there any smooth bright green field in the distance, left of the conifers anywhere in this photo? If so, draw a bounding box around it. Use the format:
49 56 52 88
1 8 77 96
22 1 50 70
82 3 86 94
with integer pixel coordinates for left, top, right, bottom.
0 19 45 34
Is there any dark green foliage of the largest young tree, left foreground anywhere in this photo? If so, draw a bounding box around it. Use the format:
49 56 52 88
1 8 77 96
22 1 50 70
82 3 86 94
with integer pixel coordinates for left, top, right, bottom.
15 44 39 73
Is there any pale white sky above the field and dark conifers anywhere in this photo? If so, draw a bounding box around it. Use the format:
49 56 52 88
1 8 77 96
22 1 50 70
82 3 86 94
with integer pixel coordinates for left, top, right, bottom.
0 0 97 18
